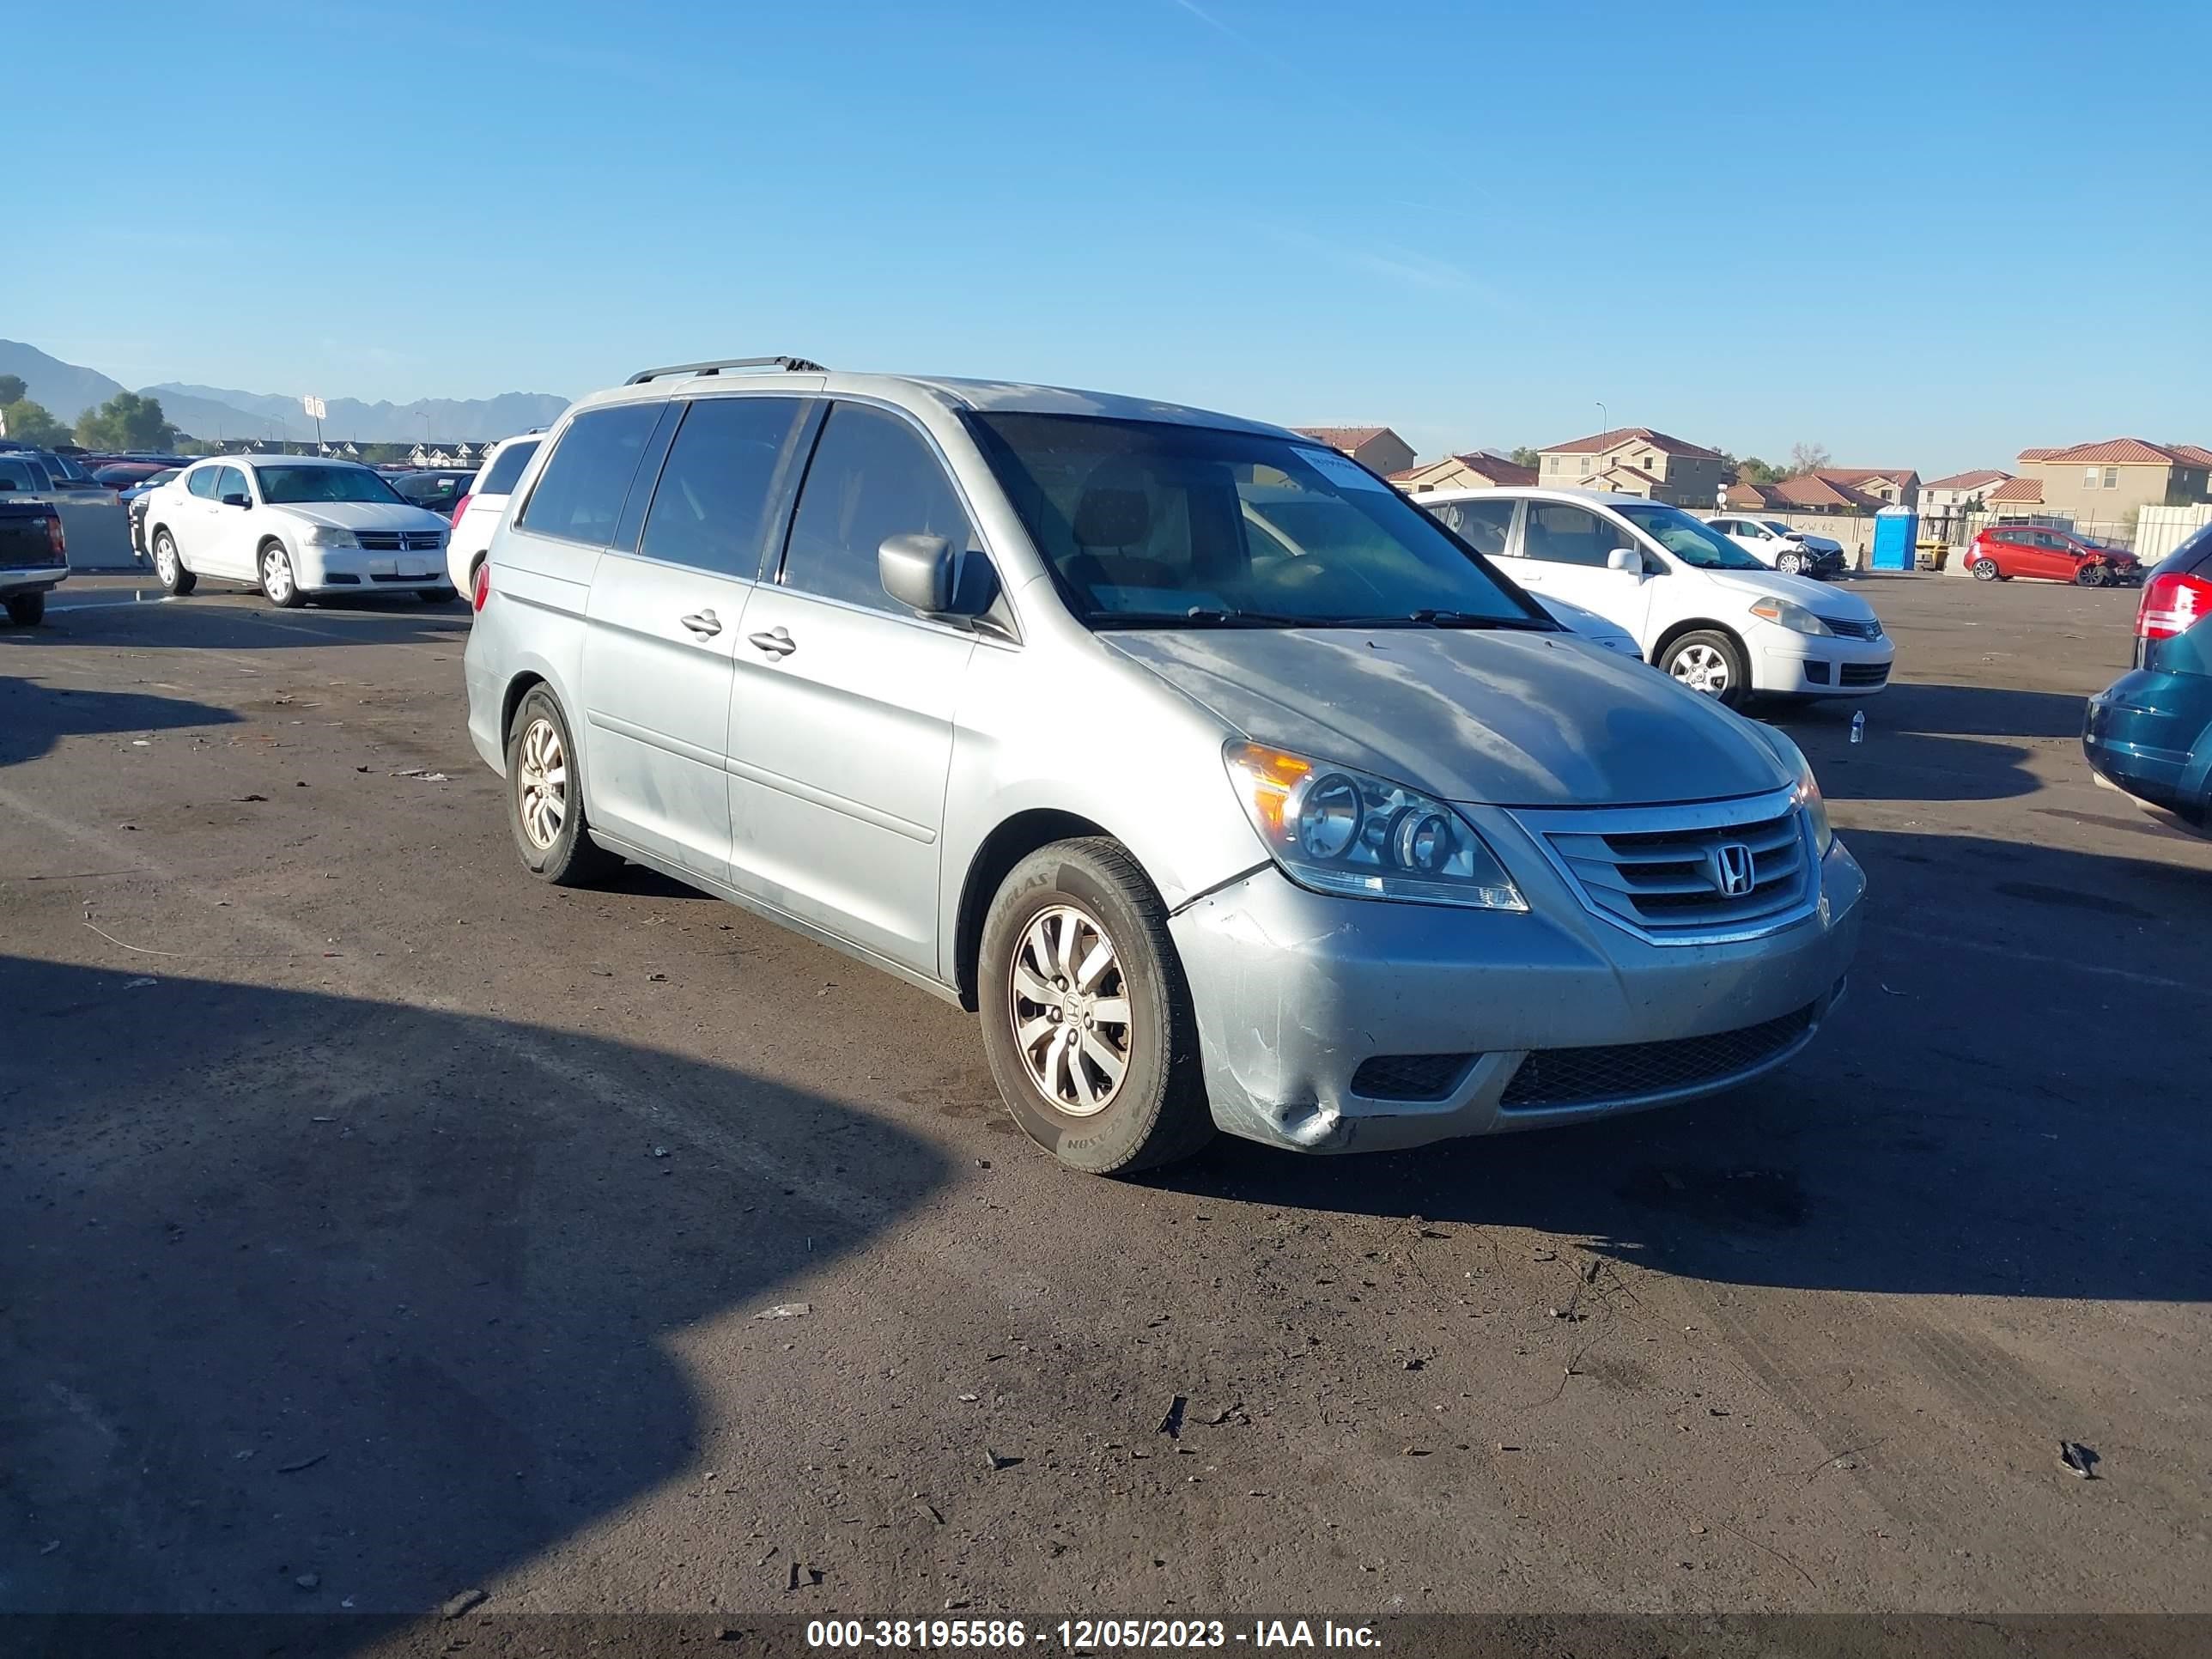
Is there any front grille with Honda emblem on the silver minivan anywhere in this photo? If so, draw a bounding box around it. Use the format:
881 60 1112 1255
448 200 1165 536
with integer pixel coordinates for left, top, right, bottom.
1517 792 1816 945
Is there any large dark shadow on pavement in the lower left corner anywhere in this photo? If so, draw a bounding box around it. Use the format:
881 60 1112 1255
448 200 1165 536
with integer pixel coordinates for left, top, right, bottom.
0 956 945 1613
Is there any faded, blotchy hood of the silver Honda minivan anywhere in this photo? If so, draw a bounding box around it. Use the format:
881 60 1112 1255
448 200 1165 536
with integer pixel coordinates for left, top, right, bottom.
1099 629 1794 807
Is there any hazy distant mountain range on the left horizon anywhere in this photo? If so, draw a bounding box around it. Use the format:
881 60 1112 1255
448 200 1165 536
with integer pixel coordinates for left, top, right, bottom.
0 341 568 442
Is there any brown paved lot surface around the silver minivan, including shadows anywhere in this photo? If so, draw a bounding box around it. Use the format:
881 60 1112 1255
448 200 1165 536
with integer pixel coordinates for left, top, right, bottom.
0 577 2212 1620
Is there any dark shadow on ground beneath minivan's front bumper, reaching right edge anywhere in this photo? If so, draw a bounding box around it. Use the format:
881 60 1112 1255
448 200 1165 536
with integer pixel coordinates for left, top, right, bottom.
1155 834 2212 1301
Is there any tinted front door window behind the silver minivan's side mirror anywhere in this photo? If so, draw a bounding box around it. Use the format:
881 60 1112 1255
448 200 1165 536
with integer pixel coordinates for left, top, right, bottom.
783 403 973 611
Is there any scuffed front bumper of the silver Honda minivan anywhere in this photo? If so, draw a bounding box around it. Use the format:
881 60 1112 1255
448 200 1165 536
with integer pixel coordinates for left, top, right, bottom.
1170 841 1865 1152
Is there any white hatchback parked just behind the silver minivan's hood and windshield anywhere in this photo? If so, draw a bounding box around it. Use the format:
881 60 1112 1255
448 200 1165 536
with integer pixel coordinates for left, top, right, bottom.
1411 489 1896 706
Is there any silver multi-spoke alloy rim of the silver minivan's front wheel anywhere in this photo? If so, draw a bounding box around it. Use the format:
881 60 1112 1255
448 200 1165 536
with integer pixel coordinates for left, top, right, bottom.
1006 905 1134 1117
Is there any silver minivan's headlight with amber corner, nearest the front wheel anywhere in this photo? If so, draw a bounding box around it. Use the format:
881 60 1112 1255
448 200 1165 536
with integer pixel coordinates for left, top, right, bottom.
1224 744 1528 909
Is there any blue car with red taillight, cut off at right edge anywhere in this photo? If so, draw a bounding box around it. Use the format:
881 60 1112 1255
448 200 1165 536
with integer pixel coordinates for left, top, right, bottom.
2081 525 2212 830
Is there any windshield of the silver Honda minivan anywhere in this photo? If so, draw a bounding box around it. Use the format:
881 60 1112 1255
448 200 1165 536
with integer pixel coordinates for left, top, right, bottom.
969 414 1553 630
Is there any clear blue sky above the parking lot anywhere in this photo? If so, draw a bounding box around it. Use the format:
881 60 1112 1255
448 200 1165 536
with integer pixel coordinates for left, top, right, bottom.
0 0 2212 476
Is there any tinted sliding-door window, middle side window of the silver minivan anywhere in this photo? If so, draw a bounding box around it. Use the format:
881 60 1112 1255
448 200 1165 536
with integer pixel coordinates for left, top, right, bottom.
637 398 805 581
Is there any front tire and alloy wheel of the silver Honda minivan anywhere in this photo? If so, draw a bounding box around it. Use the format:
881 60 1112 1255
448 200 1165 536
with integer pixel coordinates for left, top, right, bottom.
978 836 1214 1175
